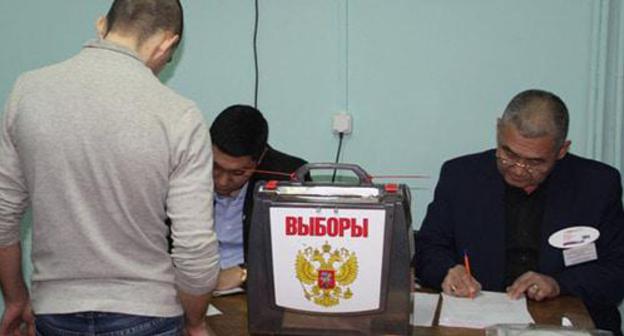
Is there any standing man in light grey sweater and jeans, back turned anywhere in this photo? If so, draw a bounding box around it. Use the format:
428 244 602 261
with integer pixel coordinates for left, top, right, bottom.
0 0 219 336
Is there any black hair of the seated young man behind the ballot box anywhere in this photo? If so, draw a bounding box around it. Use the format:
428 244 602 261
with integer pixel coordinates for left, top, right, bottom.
210 105 269 161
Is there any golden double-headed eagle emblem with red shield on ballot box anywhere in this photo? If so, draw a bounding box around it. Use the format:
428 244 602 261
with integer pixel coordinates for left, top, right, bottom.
295 242 358 307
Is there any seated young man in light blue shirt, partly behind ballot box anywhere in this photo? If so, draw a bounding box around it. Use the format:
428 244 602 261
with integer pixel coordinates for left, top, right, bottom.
210 105 306 291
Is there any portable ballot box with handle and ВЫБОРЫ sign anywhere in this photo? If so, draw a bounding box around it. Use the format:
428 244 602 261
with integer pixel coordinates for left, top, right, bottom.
247 164 412 335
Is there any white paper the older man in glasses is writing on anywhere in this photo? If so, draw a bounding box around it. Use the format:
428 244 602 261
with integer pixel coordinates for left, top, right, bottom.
439 291 535 329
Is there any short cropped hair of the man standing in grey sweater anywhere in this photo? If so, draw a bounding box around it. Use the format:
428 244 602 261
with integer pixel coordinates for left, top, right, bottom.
106 0 184 45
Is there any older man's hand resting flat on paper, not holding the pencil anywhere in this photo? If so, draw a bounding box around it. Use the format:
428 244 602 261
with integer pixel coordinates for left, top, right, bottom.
507 271 560 301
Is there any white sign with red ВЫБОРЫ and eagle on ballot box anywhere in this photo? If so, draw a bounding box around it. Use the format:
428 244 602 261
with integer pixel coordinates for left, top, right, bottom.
270 207 386 313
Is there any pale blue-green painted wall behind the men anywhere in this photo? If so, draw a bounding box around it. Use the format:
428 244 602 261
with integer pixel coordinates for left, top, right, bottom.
0 0 624 328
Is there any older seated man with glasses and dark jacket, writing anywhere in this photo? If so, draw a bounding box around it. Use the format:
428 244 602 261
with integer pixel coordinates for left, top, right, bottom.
414 90 624 335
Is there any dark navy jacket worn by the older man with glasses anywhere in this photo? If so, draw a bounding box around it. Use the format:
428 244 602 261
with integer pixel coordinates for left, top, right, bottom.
413 150 624 330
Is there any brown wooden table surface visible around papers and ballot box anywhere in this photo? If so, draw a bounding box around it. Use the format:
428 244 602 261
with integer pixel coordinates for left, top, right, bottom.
207 294 594 336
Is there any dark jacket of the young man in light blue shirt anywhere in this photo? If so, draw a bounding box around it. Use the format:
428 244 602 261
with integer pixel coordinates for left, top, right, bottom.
243 147 306 261
